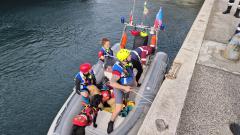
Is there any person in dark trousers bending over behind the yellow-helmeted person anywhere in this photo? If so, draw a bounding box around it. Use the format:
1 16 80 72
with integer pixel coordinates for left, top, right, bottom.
131 46 154 86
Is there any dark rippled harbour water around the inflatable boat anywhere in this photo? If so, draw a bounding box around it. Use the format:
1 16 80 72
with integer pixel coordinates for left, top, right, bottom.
0 0 202 135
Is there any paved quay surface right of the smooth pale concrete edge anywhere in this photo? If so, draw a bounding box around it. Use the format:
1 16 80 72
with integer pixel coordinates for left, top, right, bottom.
177 0 240 135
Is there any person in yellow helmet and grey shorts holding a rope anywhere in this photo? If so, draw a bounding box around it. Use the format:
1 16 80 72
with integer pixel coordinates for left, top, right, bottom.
107 49 136 133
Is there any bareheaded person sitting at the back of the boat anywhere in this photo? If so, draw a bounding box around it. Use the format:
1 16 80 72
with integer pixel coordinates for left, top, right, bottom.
98 38 113 62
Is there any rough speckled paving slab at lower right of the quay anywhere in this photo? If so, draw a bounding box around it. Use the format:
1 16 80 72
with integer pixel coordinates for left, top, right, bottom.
177 64 240 135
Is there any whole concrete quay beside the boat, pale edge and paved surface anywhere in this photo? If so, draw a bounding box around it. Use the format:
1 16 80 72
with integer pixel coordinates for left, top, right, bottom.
138 0 240 135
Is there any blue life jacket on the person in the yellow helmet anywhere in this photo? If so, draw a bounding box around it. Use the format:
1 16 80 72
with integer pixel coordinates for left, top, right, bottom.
112 61 134 85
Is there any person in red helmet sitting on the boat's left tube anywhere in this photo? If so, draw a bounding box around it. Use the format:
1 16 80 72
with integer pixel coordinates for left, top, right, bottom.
75 63 97 105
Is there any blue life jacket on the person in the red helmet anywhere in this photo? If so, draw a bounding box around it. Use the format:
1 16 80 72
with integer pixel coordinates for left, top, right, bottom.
75 70 94 89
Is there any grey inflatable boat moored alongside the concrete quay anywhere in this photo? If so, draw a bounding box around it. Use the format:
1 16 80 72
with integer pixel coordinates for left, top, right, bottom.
48 5 168 135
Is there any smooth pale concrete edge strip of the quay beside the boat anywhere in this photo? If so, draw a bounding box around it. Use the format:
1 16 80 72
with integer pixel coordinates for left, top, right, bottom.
138 0 214 135
